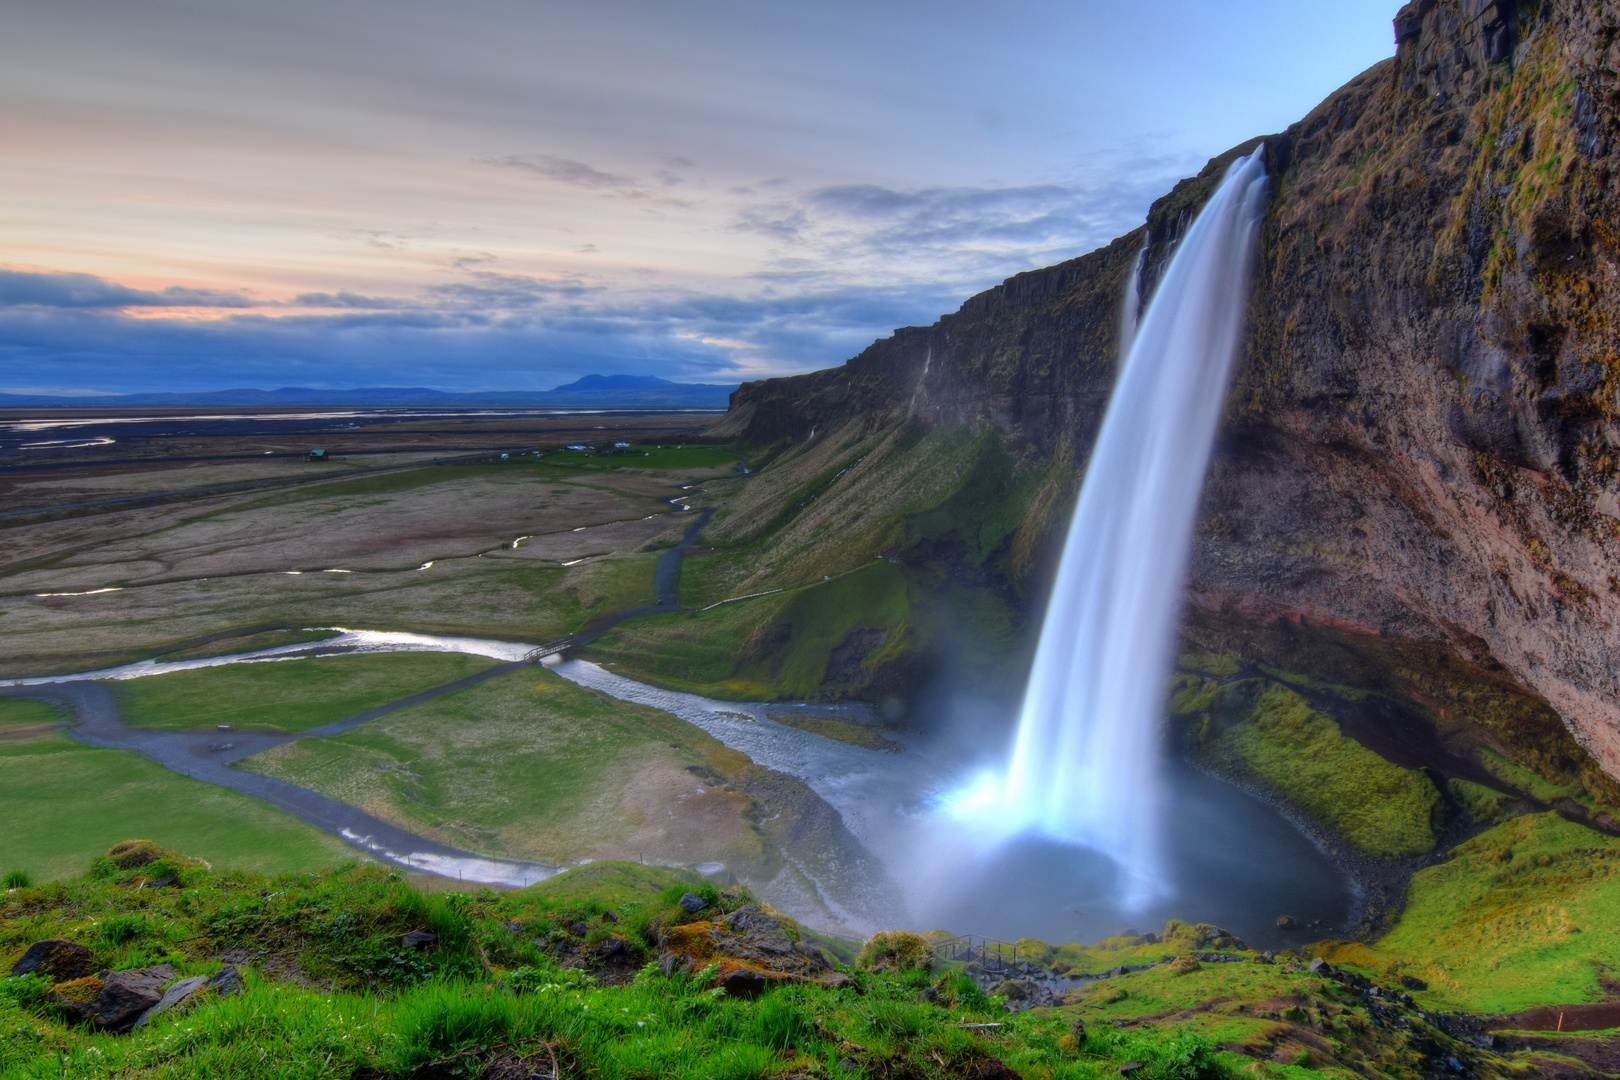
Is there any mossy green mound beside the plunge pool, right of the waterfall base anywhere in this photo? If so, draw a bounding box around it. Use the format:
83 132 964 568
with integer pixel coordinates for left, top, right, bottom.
1171 675 1443 858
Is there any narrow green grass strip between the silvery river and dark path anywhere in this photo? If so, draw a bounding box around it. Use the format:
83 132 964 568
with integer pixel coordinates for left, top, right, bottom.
113 653 496 732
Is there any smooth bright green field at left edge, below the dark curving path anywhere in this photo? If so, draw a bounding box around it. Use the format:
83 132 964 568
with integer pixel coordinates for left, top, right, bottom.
0 735 353 881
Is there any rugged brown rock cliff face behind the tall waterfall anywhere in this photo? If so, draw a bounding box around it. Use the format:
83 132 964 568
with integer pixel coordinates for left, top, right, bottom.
721 0 1620 776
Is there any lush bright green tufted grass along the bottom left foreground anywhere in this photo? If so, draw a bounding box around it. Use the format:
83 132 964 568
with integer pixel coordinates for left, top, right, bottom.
0 860 1290 1080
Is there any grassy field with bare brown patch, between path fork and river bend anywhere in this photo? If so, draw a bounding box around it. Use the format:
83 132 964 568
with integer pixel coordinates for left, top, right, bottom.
243 665 761 865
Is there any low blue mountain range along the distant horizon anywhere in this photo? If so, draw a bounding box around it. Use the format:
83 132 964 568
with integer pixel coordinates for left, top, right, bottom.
0 376 737 410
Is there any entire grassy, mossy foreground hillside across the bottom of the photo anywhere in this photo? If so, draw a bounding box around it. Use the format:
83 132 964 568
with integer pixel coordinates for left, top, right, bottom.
0 848 1601 1080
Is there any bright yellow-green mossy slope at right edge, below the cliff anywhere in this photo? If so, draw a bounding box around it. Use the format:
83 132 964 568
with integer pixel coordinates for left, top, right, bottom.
1325 813 1620 1014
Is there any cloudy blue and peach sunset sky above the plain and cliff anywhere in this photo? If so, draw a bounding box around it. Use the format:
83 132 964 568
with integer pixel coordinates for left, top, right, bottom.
0 0 1398 393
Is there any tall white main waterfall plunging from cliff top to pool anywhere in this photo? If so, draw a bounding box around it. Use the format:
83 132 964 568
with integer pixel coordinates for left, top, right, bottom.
996 151 1267 905
